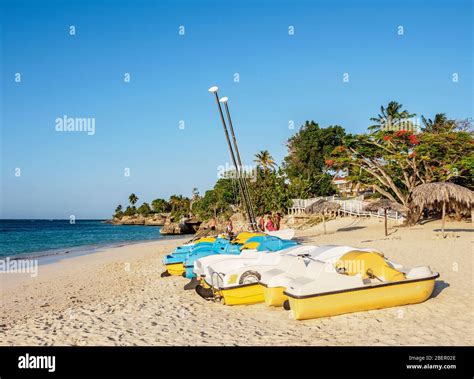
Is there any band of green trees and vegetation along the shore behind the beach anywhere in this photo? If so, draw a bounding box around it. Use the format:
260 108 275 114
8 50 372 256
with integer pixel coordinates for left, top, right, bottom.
115 101 474 226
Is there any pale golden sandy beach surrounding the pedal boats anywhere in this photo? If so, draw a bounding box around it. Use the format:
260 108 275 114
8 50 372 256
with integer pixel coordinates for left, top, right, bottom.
0 218 474 346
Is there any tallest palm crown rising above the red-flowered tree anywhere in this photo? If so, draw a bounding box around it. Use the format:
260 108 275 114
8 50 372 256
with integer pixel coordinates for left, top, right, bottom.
369 101 416 132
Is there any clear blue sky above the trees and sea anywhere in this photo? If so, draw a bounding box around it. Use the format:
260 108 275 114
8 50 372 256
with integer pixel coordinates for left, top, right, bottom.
0 0 474 218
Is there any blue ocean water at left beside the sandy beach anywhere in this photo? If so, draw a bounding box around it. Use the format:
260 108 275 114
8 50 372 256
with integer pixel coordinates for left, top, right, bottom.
0 220 172 257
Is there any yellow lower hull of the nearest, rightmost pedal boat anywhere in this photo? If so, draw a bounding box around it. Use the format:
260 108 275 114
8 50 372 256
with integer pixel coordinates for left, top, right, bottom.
285 276 438 320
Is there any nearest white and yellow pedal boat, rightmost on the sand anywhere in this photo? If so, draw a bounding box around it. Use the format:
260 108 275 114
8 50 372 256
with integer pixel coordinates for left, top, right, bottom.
284 250 439 320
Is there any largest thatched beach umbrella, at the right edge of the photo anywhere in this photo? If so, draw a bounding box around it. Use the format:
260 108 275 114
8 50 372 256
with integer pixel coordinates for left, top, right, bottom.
412 182 474 237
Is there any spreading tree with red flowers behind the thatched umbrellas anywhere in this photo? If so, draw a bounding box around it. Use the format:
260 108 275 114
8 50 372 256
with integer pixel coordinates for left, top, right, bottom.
326 130 474 222
